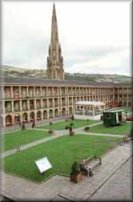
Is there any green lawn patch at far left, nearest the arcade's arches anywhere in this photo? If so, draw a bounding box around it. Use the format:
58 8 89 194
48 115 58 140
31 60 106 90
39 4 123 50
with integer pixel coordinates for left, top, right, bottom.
3 129 50 151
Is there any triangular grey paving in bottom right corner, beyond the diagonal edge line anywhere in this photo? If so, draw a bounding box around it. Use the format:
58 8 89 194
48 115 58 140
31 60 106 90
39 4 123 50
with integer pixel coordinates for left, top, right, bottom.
91 158 133 201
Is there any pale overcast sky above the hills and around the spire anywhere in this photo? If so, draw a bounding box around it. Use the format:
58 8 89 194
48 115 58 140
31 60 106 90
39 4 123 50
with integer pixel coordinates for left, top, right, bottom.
2 1 131 75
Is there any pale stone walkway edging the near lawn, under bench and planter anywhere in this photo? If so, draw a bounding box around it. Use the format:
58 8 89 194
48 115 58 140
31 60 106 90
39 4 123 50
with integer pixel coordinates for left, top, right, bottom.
1 142 132 201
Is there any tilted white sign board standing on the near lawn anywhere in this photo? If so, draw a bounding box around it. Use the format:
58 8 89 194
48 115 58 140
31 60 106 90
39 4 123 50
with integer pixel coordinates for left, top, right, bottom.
35 157 52 173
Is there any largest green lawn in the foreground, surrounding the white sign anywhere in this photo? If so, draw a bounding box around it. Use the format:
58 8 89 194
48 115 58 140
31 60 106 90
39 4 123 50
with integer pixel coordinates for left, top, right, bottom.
4 134 121 182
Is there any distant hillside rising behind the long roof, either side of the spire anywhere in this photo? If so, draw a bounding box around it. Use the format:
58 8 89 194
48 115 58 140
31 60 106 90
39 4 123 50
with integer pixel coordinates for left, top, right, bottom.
1 65 131 83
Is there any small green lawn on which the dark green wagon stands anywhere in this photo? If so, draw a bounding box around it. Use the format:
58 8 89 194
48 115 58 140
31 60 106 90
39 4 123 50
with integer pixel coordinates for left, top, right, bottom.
89 122 131 135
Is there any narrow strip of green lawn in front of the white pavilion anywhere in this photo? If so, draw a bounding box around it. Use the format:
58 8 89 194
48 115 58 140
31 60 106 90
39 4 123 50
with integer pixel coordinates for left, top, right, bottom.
39 119 98 130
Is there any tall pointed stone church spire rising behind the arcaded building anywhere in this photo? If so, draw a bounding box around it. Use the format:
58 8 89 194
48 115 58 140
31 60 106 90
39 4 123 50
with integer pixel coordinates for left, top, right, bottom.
47 4 64 80
